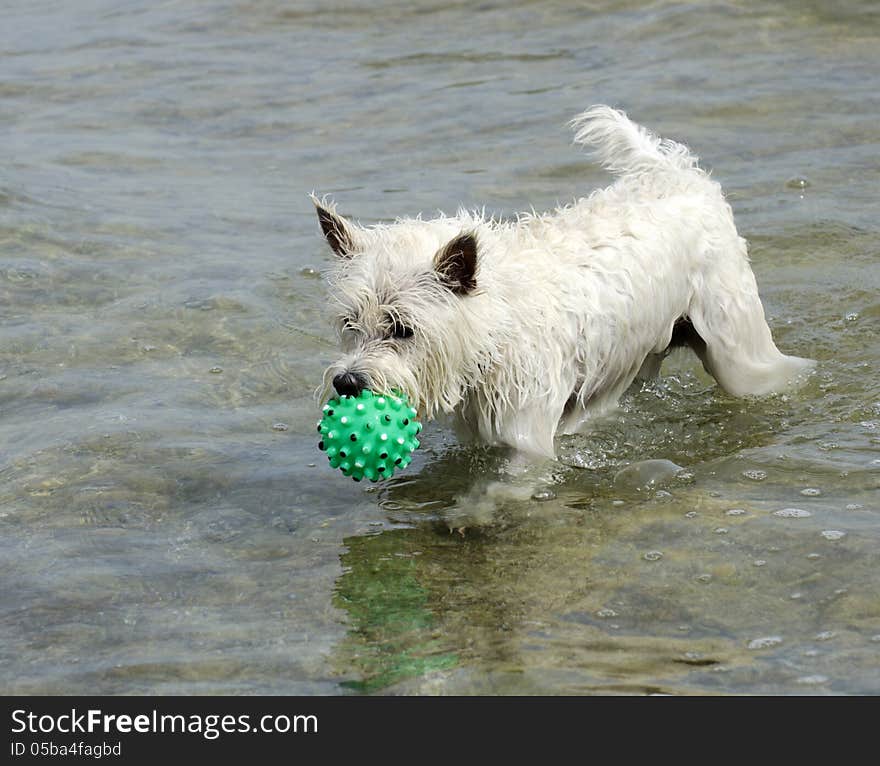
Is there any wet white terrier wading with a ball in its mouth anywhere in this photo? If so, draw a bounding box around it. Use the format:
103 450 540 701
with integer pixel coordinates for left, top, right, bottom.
313 106 813 459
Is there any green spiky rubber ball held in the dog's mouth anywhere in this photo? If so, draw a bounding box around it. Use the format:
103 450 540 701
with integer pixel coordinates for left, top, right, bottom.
318 389 422 481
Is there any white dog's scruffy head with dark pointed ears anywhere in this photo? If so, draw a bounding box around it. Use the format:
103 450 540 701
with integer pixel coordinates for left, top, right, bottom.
312 196 482 417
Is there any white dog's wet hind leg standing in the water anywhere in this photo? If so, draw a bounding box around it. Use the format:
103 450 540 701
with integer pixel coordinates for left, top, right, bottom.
688 237 815 396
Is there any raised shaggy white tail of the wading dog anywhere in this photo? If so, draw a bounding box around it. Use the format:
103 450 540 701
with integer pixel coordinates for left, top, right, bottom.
569 104 703 175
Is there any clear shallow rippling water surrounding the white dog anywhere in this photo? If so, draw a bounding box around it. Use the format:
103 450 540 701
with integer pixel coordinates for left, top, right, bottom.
0 0 880 694
